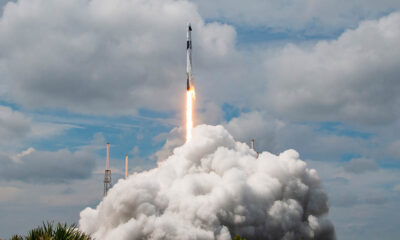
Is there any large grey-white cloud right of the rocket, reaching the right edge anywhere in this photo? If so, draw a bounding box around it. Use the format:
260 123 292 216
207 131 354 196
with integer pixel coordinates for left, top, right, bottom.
259 12 400 124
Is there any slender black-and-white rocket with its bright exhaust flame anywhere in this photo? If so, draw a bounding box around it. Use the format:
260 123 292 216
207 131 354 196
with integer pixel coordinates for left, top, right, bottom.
186 23 195 142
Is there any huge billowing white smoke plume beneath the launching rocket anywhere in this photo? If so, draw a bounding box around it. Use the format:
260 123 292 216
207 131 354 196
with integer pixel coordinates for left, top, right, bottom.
79 125 335 240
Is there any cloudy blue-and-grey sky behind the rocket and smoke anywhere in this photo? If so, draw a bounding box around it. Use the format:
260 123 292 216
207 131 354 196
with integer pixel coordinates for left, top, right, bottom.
0 0 400 239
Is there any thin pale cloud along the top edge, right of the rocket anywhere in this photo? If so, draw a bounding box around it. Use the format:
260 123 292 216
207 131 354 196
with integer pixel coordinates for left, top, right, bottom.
194 0 400 34
